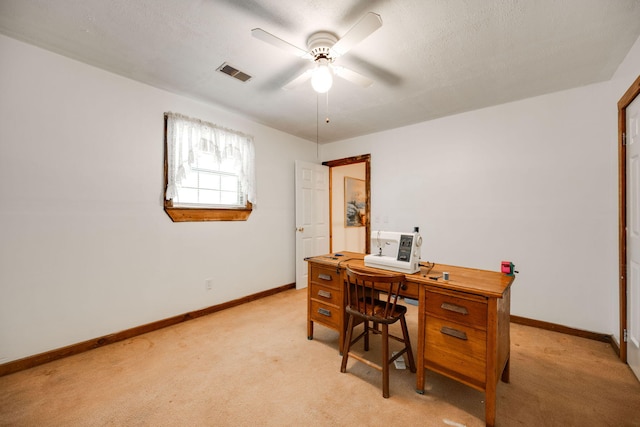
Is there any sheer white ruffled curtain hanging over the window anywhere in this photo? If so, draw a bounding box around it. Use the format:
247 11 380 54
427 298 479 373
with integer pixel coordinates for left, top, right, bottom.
165 113 256 205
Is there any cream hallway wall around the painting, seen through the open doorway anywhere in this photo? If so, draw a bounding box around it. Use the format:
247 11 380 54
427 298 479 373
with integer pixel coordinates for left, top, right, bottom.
331 163 366 253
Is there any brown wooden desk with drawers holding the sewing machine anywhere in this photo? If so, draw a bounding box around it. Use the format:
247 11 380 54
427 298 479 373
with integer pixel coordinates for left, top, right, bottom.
307 252 514 426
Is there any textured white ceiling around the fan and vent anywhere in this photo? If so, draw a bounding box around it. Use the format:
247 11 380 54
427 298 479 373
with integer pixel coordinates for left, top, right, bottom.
0 0 640 143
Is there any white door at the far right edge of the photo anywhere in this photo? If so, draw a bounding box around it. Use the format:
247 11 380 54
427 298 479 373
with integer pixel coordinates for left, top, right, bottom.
626 97 640 379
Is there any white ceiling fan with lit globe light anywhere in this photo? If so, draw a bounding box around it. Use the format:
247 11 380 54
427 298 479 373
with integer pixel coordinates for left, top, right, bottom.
251 12 382 93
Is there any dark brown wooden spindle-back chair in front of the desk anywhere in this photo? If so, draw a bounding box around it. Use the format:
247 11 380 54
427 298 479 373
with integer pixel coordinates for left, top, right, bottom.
340 268 416 398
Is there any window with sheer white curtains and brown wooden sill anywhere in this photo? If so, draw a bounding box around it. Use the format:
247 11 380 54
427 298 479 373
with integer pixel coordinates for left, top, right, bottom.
165 113 255 221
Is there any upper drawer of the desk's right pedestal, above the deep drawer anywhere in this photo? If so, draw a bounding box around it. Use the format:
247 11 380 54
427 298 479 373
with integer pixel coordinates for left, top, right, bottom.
426 290 487 330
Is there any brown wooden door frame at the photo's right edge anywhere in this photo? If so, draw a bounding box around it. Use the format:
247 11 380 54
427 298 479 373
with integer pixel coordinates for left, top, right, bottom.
618 76 640 363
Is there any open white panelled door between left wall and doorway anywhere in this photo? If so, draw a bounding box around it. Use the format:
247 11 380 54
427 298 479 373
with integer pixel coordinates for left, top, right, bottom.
296 160 329 289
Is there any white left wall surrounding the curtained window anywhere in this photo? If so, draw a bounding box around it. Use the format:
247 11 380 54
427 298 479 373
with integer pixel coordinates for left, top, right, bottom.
0 36 317 363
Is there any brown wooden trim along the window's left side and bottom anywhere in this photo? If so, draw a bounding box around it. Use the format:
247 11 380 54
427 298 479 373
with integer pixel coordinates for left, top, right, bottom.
163 114 253 222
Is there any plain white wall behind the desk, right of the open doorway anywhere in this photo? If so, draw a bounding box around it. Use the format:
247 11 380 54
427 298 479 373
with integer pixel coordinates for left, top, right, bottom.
321 35 640 336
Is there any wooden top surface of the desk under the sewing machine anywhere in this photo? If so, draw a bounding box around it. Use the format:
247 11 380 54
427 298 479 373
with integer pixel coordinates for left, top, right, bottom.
307 252 515 298
